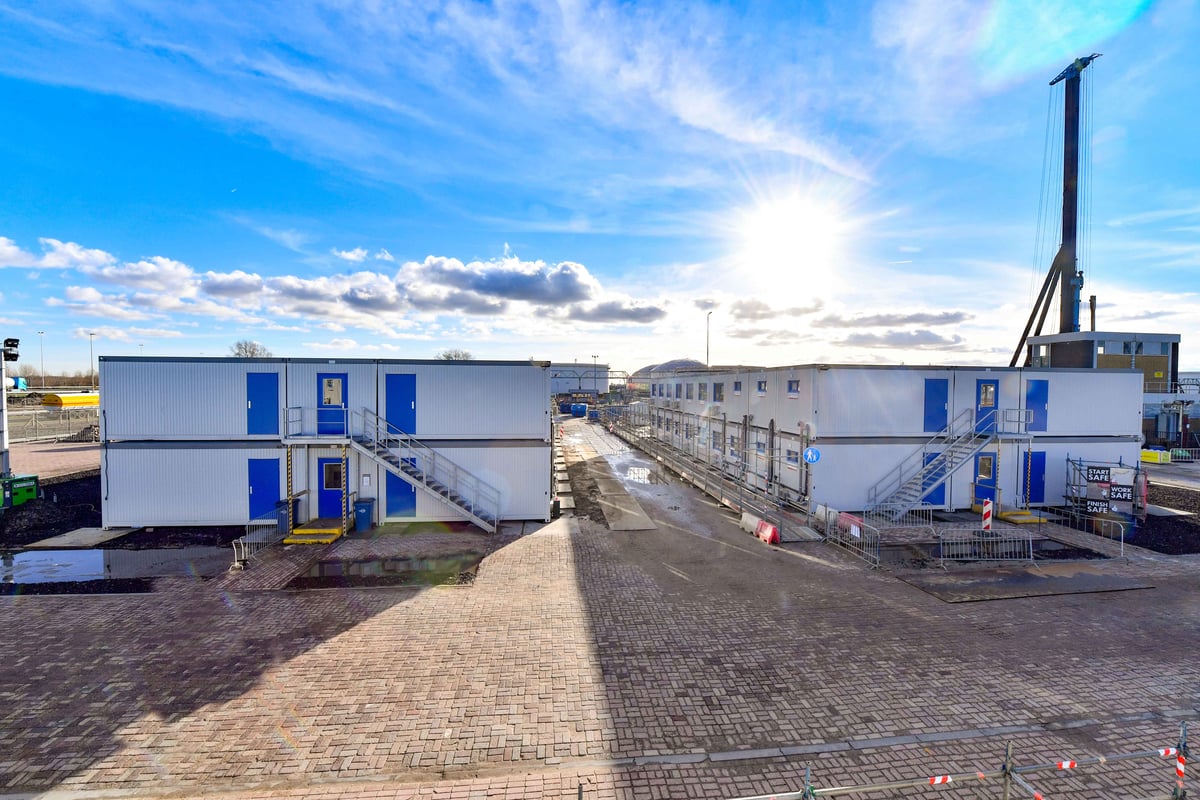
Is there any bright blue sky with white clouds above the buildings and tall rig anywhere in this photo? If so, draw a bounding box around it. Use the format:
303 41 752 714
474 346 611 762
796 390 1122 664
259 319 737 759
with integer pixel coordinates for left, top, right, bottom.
0 0 1200 372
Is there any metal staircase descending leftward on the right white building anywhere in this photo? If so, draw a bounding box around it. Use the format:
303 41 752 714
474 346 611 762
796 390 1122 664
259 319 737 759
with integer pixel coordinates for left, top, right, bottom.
864 408 997 525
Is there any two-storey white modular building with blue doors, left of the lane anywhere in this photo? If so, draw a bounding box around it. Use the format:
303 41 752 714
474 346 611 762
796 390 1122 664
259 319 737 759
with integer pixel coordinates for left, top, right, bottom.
100 356 552 530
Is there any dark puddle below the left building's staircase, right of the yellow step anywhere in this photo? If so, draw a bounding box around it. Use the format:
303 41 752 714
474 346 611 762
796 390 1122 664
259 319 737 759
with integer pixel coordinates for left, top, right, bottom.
288 553 484 589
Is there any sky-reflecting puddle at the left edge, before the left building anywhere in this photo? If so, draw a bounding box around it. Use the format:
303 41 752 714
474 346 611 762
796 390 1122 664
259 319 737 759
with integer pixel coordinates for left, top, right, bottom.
0 547 233 584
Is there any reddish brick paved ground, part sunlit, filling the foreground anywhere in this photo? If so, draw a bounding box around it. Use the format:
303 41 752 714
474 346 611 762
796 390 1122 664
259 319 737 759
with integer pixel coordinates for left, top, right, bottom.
0 422 1200 799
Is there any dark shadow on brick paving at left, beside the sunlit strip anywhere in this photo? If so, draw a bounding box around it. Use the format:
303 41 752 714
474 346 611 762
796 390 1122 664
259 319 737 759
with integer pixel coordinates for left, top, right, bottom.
0 581 419 792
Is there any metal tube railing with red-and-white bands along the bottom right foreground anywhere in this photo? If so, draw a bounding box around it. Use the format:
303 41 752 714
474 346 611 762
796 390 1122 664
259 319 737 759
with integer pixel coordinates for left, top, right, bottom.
732 722 1189 800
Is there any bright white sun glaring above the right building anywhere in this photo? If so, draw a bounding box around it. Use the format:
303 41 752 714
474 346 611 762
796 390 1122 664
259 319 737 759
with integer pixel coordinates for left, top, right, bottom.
734 192 848 299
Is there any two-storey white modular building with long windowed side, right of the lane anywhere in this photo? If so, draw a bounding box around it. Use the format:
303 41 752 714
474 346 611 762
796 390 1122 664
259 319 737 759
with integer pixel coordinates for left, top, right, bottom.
635 365 1142 511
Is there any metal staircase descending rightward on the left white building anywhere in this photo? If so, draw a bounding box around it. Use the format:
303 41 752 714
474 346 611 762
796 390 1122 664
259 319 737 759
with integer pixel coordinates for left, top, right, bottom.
350 409 500 534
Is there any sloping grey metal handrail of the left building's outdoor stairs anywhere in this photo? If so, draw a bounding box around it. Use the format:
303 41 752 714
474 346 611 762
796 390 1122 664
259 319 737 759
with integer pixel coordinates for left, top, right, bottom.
352 408 500 524
